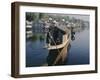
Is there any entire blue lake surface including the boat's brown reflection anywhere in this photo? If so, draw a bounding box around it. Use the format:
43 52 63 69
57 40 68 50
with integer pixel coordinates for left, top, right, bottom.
26 26 89 67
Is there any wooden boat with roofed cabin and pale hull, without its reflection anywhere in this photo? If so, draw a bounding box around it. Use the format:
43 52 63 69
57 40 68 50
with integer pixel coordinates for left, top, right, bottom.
45 25 71 50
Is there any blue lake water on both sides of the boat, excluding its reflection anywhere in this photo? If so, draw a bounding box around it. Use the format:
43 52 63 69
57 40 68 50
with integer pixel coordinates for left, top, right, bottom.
26 28 89 67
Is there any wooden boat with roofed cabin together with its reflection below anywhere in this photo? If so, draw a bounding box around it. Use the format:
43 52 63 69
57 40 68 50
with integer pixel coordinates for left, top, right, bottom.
45 23 71 66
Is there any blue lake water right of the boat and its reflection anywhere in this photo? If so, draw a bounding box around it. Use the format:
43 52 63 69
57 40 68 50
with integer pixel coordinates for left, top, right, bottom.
67 29 89 65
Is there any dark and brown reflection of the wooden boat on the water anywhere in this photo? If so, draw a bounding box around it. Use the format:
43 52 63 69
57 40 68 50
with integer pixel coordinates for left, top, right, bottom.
47 43 71 66
